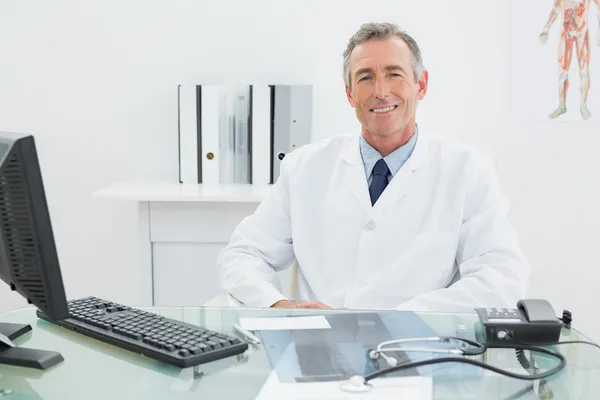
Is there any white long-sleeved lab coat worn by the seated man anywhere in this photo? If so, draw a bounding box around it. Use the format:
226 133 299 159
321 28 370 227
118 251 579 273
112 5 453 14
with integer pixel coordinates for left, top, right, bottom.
218 129 530 311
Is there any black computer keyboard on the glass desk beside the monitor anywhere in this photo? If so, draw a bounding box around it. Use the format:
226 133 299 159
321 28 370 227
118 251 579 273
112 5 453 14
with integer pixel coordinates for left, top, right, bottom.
37 297 248 368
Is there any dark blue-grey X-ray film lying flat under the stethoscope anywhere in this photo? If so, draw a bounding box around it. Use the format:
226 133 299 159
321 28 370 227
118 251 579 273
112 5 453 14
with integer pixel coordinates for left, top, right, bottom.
259 311 481 383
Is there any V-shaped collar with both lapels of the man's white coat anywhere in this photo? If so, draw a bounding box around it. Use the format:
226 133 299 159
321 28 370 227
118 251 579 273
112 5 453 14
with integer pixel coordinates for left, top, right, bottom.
342 129 429 213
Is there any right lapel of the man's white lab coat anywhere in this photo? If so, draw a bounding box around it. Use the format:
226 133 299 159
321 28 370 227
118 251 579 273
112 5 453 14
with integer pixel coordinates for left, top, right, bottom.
373 131 429 211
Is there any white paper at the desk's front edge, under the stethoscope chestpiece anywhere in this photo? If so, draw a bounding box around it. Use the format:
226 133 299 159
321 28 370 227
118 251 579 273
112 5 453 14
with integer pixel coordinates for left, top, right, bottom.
256 371 433 400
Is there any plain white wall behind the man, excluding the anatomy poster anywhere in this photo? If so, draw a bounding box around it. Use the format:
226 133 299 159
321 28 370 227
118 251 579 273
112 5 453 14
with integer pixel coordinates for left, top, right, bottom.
0 0 600 342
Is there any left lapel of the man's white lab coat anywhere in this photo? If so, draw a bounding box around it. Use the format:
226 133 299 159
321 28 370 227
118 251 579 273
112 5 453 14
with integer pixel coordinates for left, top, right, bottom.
341 136 371 212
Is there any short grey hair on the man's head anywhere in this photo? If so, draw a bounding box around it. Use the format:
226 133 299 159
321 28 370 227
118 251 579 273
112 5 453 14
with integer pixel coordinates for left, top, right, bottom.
344 22 425 87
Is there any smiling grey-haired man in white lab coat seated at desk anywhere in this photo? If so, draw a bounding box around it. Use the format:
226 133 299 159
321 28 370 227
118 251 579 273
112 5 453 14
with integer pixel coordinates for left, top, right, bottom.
219 23 530 311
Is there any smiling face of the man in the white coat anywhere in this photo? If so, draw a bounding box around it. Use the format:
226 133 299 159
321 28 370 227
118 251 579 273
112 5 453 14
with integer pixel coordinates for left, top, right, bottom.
346 38 427 136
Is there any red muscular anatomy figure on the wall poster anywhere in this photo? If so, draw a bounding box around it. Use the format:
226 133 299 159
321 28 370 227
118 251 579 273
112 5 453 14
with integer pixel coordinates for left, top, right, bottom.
540 0 600 119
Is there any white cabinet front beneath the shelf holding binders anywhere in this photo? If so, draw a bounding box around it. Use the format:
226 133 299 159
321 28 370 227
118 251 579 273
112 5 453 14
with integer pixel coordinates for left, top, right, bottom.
150 202 292 307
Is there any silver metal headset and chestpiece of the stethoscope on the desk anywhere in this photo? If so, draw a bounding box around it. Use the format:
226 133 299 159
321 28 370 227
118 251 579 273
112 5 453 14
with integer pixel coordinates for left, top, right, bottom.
340 336 486 393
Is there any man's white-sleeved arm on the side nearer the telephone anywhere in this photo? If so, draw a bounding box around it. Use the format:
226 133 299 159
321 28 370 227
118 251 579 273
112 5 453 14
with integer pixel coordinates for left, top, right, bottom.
397 156 531 312
